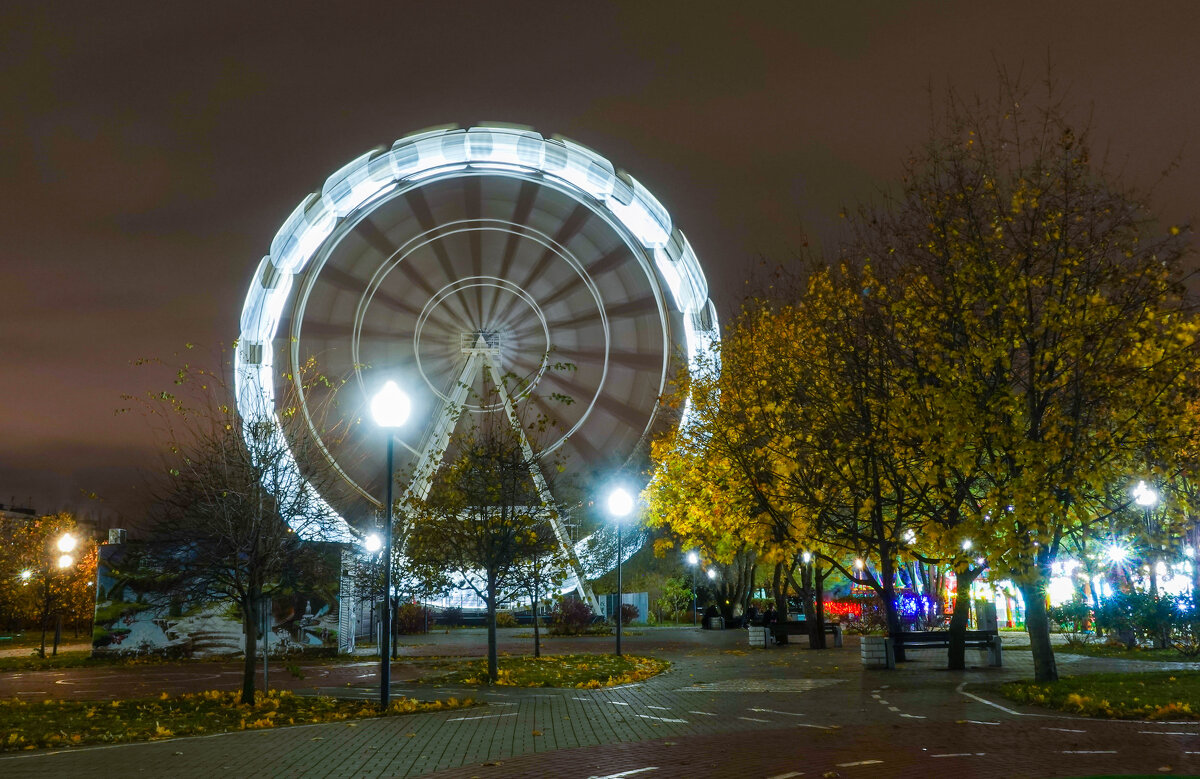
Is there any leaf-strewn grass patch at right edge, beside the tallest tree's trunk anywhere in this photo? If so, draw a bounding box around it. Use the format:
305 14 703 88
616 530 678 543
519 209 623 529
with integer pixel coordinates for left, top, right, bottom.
995 671 1200 720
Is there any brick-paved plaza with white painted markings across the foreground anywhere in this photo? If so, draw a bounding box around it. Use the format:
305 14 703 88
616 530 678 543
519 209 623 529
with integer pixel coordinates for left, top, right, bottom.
0 628 1200 779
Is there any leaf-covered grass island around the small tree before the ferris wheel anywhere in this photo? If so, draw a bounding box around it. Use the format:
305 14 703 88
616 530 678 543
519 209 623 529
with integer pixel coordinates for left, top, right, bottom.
420 654 671 689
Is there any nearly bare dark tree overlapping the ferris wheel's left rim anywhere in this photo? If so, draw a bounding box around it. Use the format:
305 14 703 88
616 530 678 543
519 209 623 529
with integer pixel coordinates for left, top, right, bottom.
130 350 340 703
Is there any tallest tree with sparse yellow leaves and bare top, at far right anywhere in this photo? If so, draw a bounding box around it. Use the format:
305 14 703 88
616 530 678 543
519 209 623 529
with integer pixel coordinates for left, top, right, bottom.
860 83 1198 681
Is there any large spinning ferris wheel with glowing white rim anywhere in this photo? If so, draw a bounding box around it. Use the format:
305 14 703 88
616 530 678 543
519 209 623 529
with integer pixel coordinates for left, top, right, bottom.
235 126 718 602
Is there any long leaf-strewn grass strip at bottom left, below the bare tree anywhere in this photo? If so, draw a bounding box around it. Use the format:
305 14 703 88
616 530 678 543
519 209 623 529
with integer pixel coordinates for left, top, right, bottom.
0 690 475 751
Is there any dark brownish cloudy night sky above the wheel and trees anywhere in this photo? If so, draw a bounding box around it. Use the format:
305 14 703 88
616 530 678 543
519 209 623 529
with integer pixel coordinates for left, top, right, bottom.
0 0 1200 523
